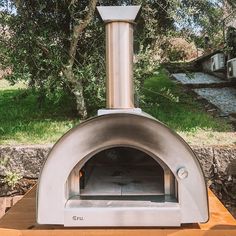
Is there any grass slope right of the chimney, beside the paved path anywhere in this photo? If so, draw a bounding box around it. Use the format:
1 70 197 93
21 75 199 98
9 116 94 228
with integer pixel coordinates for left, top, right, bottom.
143 70 233 145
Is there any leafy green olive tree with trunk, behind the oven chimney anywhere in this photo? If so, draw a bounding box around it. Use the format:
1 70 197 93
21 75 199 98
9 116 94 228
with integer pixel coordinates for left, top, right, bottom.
0 0 225 118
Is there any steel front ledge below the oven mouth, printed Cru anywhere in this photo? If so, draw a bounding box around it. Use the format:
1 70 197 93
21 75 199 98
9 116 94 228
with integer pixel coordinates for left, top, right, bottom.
64 200 181 227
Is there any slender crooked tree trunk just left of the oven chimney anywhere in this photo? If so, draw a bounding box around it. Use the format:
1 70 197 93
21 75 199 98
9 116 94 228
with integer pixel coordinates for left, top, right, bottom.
63 0 97 119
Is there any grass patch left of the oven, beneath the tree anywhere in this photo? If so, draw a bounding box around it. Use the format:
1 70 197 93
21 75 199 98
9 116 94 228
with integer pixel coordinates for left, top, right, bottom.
0 81 79 144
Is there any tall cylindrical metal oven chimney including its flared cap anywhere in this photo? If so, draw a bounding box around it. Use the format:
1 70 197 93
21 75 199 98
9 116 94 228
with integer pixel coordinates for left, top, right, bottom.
97 6 140 109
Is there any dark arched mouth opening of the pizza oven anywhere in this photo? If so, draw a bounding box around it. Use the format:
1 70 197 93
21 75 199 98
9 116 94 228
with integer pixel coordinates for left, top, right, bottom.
67 146 178 205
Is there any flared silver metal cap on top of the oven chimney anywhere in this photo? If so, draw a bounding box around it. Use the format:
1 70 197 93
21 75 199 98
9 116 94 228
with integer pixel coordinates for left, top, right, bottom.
97 6 141 22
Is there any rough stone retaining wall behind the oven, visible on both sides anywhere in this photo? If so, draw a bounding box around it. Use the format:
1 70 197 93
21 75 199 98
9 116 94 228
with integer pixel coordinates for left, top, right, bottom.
0 146 236 215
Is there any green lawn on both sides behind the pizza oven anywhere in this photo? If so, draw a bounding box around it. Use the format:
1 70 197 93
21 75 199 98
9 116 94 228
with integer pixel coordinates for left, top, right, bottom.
0 70 234 145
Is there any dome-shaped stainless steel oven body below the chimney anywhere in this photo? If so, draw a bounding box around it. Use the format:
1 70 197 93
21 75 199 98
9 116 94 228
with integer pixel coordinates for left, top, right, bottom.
37 113 208 226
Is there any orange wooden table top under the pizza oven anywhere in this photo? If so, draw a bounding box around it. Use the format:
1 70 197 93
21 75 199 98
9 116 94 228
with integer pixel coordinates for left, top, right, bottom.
0 187 236 236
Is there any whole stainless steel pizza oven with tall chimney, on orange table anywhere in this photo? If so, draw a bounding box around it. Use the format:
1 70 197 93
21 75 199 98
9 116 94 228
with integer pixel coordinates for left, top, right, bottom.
37 6 208 227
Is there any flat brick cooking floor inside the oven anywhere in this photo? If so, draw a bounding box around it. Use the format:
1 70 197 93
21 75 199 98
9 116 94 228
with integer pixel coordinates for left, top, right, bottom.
81 165 164 196
